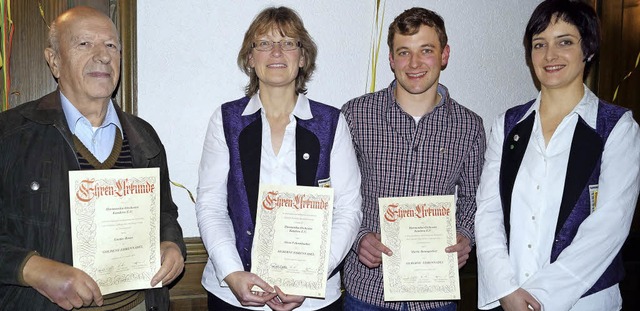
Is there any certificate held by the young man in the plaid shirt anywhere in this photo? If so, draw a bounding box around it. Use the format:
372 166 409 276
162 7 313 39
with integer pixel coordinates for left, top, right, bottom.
378 195 460 301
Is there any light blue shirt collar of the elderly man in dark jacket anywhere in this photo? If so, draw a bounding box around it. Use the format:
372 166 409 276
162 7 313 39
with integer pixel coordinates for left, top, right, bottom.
60 92 122 162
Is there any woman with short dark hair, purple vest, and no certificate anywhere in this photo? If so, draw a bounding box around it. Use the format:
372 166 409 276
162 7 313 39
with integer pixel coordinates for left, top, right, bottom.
476 0 640 311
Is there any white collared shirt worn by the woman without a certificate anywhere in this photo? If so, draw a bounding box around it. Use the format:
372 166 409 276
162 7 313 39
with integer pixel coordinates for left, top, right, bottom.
476 86 640 311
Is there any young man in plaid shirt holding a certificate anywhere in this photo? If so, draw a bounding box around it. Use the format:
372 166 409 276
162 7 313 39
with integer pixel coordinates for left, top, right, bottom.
342 8 485 310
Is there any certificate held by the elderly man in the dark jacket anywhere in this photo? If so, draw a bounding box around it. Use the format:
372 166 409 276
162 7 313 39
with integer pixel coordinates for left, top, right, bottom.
69 168 162 295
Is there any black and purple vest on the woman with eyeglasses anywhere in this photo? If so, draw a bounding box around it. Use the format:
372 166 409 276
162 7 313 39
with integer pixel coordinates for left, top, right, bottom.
221 97 340 271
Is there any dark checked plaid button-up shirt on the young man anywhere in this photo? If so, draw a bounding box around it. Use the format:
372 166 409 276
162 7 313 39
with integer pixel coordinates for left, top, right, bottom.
342 81 486 310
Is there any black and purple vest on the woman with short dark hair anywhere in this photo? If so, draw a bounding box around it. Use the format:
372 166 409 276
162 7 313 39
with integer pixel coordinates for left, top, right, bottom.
500 100 627 297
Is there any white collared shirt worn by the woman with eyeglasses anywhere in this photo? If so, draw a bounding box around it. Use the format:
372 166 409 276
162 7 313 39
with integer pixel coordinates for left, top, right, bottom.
196 94 362 310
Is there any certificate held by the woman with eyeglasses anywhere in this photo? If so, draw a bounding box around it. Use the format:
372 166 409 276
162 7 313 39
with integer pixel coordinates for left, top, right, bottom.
251 184 333 298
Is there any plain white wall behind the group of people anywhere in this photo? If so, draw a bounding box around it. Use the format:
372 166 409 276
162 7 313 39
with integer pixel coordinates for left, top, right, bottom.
137 0 540 236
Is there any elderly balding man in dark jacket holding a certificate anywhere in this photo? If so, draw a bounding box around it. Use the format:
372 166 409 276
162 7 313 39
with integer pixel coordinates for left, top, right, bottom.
0 7 185 310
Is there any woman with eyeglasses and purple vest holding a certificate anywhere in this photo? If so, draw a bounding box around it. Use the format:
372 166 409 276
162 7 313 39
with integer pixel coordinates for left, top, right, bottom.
196 7 362 310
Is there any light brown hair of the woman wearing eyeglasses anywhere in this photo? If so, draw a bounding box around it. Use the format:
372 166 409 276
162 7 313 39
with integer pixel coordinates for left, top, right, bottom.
238 6 318 97
